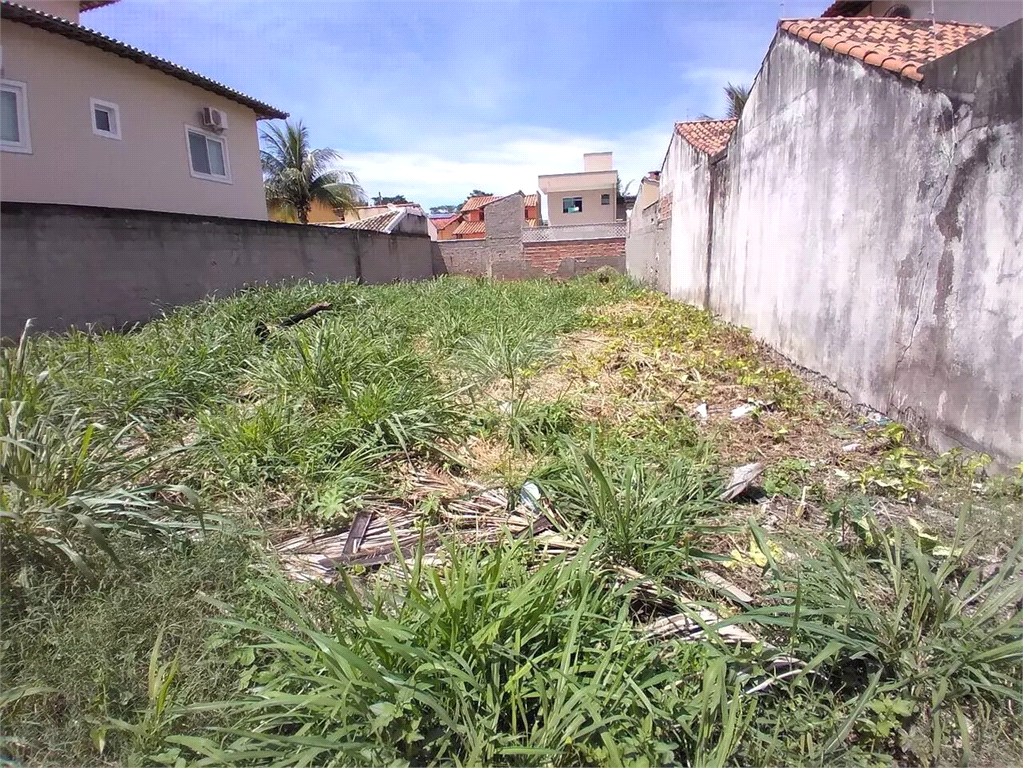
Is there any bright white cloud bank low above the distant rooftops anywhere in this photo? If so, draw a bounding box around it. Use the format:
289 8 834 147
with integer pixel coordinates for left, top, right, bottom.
344 123 672 213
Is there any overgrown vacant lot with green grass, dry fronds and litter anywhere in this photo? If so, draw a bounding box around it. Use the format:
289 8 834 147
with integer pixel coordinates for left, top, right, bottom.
0 276 1023 766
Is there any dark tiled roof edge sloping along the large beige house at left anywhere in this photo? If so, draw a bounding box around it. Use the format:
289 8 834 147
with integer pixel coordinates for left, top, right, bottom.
0 0 287 120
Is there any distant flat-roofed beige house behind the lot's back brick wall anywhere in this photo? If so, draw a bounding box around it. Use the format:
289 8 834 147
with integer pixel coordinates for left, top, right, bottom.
538 152 618 226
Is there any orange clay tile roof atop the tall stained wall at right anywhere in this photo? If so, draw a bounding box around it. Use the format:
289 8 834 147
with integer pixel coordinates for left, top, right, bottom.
779 16 991 80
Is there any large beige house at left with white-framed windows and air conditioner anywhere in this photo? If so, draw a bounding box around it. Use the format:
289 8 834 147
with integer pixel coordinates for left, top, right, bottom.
0 0 287 220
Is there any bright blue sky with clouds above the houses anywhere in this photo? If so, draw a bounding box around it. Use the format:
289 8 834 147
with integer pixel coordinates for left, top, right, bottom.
82 0 828 206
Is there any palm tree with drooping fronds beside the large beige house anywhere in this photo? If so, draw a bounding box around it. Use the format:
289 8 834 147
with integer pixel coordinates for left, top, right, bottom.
260 121 365 224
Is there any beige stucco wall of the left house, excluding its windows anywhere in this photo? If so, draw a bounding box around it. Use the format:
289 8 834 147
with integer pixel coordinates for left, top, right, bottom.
0 20 267 220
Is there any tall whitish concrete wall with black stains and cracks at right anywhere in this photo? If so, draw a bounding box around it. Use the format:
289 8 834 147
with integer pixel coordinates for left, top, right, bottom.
712 22 1023 465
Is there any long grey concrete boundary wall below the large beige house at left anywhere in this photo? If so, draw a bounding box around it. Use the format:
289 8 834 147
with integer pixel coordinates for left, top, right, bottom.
0 202 434 336
